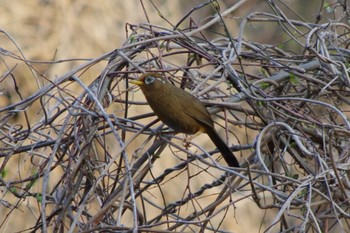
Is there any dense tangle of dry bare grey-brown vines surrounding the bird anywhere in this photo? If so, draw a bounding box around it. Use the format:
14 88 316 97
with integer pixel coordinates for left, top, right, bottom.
0 1 350 232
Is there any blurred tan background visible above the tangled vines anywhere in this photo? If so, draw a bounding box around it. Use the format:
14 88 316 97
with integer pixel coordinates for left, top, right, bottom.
0 0 337 106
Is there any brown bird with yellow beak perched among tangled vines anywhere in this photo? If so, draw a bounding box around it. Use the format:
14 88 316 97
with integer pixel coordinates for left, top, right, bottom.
130 73 239 167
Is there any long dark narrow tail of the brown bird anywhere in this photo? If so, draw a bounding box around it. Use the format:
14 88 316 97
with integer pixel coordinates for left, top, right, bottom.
206 127 239 167
